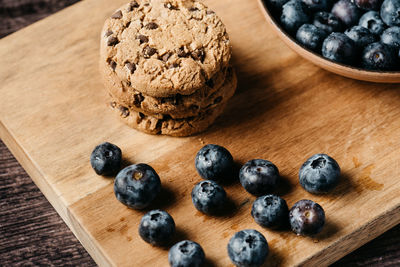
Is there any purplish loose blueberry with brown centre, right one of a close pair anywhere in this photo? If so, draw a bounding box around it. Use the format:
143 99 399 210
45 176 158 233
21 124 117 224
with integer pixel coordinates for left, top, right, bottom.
289 199 325 235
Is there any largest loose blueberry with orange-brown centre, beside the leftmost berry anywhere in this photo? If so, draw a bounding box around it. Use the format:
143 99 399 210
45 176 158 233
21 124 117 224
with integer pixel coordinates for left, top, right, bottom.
114 163 161 209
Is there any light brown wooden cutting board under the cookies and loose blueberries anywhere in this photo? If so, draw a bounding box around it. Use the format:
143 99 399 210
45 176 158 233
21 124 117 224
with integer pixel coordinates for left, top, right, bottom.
0 0 400 266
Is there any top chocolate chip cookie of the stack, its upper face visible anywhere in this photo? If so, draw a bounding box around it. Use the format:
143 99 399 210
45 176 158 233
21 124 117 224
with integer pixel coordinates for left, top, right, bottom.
100 0 231 97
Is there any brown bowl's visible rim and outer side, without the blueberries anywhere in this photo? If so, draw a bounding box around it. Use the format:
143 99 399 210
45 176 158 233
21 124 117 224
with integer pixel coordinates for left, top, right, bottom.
258 0 400 83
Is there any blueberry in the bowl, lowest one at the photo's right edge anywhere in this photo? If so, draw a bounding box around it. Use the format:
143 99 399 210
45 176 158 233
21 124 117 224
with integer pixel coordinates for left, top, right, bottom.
361 42 398 70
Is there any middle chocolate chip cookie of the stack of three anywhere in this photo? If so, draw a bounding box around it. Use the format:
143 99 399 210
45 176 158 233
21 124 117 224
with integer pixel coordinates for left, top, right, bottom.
105 67 237 119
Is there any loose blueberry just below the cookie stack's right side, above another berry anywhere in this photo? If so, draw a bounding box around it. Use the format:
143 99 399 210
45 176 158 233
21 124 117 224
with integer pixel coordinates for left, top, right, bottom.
195 144 234 180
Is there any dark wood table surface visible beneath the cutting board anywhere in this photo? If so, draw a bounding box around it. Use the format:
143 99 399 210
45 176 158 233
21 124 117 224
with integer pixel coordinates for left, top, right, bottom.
0 0 400 266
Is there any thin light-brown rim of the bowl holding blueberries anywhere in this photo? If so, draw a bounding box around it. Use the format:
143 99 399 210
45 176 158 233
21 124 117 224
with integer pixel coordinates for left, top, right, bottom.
258 0 400 78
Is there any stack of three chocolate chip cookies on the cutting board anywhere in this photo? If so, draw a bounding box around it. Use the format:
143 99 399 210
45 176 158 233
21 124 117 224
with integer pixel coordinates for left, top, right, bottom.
100 0 237 136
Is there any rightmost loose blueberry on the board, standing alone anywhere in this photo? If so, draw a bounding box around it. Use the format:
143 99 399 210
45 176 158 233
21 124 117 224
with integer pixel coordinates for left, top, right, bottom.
299 154 340 194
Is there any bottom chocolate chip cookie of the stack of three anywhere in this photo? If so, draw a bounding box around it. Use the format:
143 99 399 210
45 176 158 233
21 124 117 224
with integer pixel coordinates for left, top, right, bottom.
111 102 226 137
